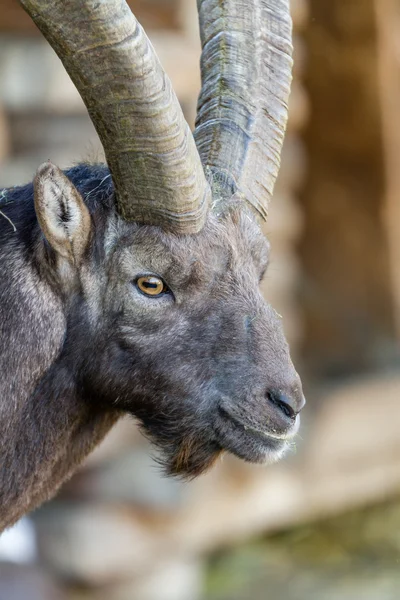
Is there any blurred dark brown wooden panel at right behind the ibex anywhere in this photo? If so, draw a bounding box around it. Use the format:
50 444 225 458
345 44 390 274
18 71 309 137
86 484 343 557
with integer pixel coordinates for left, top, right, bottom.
300 0 400 377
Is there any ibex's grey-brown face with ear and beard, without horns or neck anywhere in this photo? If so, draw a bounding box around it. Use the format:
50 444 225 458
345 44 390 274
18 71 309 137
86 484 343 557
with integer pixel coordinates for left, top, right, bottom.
35 164 304 476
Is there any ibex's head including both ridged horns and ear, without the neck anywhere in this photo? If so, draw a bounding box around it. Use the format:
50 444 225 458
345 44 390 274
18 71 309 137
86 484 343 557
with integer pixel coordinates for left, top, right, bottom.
21 0 304 476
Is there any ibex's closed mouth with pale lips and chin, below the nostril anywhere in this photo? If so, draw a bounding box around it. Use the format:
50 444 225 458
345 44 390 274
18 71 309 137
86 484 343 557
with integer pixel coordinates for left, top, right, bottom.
215 406 300 464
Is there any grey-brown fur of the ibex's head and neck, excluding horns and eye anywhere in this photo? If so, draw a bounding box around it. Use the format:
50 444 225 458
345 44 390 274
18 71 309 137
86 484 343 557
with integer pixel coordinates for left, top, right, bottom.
0 165 304 530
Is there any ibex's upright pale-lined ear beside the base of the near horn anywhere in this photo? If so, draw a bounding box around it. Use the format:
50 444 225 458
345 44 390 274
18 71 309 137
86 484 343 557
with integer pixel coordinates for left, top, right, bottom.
34 162 91 265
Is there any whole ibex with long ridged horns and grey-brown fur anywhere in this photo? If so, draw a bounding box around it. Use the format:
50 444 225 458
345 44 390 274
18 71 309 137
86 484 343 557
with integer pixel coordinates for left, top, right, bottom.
0 0 304 530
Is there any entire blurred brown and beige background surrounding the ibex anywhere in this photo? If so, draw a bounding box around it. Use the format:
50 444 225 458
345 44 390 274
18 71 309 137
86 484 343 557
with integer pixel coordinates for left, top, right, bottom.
0 0 400 600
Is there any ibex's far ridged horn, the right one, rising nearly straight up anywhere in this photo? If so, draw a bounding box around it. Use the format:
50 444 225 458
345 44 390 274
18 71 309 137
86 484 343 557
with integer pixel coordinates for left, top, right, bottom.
194 0 292 218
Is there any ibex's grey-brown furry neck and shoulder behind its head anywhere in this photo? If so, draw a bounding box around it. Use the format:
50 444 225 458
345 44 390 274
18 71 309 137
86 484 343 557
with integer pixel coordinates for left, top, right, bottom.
0 221 118 531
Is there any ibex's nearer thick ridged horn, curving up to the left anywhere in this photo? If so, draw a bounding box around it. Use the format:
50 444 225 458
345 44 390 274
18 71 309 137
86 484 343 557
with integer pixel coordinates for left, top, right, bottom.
20 0 209 233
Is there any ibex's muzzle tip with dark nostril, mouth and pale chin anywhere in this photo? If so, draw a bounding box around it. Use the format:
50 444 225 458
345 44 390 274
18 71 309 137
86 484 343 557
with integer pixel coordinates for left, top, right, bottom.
216 381 306 463
